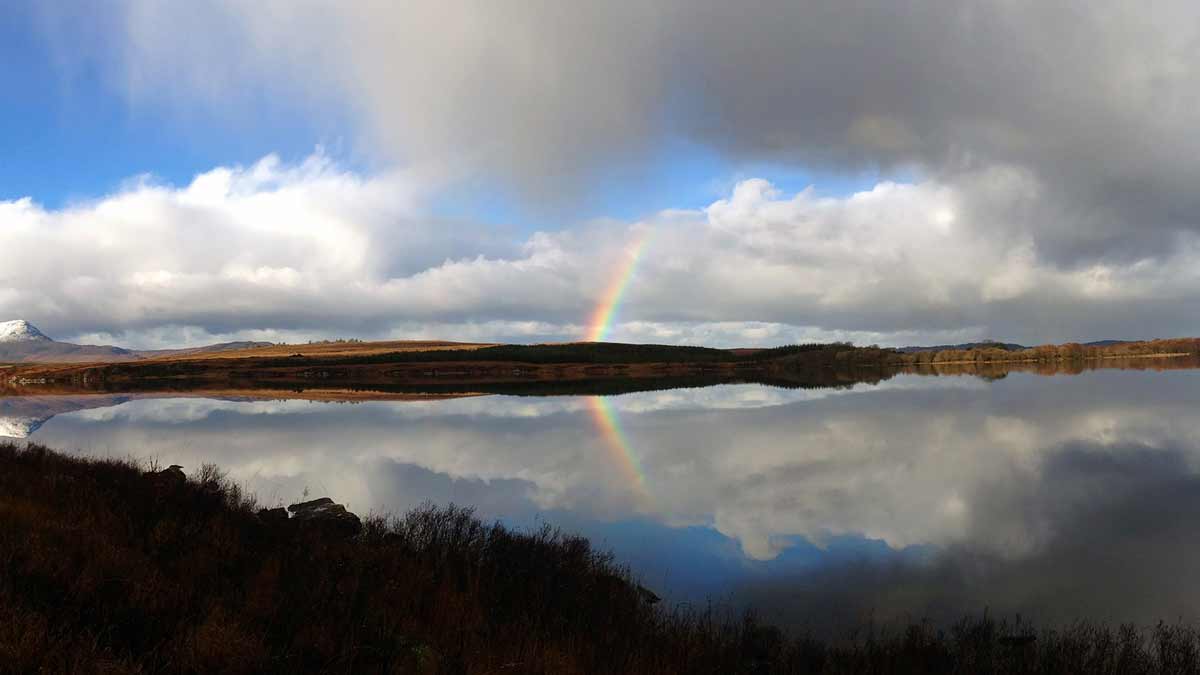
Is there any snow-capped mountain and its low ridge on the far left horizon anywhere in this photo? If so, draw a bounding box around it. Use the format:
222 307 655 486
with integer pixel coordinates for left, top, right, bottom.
0 319 271 363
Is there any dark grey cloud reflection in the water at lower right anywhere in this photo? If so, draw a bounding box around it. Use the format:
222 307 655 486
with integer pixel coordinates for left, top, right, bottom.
738 442 1200 629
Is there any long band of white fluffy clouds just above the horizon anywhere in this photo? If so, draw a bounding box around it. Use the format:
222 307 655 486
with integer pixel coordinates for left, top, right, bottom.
0 153 1200 346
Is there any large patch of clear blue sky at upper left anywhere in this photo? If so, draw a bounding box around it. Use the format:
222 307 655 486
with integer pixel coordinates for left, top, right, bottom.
0 2 344 208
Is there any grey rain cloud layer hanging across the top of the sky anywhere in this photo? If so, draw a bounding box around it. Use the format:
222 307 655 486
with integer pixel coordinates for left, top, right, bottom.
42 0 1200 260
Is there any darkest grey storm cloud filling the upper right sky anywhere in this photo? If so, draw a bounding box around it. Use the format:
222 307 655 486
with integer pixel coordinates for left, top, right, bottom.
679 1 1200 253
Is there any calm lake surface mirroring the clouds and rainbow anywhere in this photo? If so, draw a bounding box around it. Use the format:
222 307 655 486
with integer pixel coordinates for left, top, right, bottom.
0 370 1200 632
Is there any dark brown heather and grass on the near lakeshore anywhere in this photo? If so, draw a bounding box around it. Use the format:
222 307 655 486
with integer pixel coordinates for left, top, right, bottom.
7 444 1200 674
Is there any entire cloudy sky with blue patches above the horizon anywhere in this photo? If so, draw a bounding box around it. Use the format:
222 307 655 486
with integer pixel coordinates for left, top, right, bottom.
7 0 1200 347
